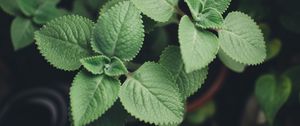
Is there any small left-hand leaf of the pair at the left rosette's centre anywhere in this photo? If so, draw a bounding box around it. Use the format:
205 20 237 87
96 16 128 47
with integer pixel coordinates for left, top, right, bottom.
80 56 110 74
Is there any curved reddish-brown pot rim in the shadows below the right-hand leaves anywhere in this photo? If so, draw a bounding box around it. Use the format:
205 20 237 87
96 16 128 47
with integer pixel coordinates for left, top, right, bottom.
186 66 229 112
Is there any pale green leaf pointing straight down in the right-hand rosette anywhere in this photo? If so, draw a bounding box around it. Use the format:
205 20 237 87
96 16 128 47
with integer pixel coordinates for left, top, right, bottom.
178 16 219 73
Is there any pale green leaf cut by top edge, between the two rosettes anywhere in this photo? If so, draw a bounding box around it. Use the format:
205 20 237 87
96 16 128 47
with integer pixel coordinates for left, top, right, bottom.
131 0 178 22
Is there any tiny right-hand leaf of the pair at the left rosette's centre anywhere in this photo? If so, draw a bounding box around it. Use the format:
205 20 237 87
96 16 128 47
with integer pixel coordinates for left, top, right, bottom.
104 57 128 76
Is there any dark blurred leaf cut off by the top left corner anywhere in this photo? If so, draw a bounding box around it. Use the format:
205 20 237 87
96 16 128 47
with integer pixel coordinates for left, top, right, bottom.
0 0 21 16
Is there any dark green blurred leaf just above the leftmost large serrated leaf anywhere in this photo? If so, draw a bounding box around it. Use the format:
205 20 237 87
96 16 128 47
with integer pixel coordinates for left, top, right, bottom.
33 1 67 24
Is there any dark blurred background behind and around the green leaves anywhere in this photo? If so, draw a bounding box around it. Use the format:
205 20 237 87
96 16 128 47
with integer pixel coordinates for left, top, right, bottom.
0 0 300 126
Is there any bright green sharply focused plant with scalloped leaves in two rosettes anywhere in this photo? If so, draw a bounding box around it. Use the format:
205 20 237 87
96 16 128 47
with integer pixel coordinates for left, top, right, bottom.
35 0 266 126
